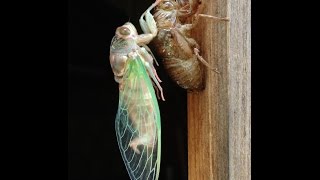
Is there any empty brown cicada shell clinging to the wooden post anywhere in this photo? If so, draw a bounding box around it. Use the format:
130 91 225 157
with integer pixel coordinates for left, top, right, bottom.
152 0 228 91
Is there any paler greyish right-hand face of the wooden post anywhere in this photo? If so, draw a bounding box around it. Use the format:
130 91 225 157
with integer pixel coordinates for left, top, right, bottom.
229 0 251 180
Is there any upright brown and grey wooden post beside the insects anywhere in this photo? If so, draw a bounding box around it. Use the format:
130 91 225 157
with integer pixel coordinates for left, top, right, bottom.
188 0 251 180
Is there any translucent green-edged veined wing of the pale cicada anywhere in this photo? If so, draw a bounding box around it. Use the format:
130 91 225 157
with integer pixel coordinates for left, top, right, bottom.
115 56 161 180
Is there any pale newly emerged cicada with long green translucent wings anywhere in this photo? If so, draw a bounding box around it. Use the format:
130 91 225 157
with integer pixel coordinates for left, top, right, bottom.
110 0 164 180
